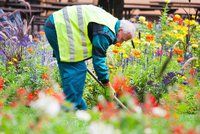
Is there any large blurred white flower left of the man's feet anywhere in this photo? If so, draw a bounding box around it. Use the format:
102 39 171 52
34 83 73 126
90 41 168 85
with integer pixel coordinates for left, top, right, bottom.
30 92 61 117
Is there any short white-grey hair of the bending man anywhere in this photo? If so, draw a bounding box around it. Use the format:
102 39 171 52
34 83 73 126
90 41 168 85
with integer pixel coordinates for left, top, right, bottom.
120 20 136 38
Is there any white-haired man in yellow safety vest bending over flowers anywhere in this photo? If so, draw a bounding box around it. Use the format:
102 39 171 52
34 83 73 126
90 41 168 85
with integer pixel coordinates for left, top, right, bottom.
44 5 135 110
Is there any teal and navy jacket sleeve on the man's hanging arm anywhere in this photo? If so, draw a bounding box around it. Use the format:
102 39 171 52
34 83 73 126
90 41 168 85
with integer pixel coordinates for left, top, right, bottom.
92 34 110 84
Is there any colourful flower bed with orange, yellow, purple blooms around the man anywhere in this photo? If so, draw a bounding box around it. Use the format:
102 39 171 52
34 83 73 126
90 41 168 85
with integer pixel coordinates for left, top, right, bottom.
0 3 200 134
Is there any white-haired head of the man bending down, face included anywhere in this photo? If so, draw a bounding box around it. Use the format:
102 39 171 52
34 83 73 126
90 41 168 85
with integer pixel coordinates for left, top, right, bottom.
117 20 136 43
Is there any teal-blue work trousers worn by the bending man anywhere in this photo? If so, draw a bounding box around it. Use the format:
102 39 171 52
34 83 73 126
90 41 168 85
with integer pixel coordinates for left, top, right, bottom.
44 16 87 110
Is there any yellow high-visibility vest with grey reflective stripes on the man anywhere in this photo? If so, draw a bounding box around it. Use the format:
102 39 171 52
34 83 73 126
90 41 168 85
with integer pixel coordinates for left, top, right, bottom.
53 5 118 62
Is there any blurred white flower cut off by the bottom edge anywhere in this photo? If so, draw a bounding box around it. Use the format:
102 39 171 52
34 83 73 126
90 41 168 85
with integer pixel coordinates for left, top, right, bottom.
89 122 120 134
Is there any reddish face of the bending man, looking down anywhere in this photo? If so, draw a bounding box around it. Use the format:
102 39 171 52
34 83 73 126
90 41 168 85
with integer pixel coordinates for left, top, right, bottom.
117 29 132 43
